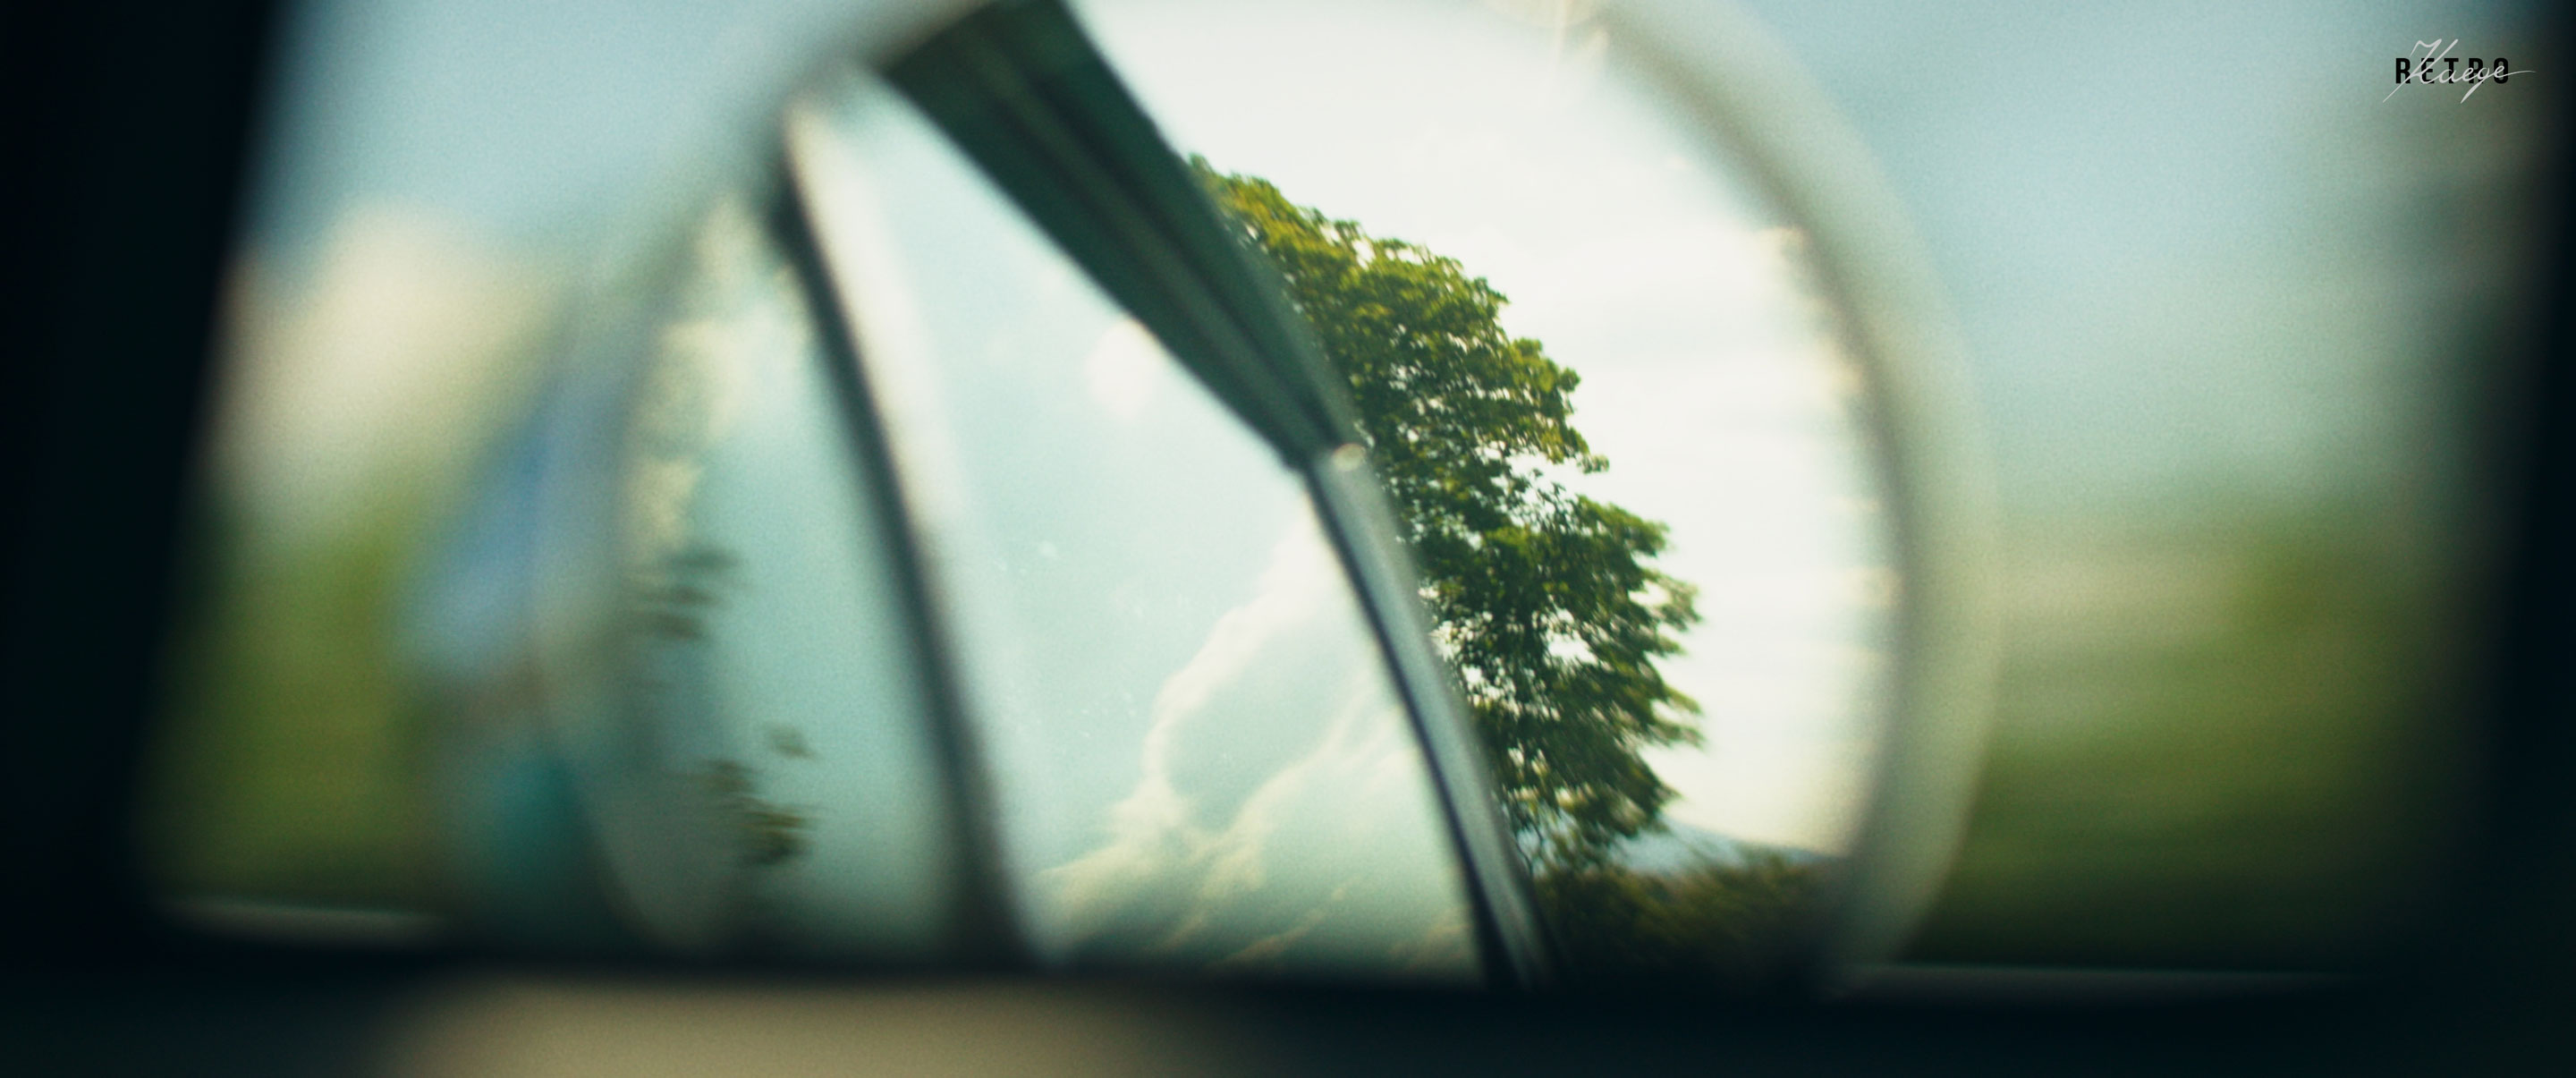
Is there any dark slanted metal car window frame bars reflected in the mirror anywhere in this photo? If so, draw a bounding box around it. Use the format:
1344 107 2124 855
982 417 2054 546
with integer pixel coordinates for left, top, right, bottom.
770 0 1554 990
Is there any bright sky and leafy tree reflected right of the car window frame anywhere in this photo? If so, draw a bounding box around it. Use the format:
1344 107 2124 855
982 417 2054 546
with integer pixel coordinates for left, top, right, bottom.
1077 0 1899 982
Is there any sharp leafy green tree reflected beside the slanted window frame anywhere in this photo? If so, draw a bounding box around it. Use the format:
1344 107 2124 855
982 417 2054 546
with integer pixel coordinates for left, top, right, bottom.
1195 163 1700 869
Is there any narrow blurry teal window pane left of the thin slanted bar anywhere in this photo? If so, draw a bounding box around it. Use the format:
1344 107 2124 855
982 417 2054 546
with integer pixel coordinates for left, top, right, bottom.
623 201 958 957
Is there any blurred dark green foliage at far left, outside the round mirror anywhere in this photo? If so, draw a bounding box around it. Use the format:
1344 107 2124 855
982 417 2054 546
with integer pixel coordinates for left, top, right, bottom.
137 500 436 911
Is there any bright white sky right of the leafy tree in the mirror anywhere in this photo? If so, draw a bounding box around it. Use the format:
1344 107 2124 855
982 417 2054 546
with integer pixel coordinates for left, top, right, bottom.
1077 0 1896 851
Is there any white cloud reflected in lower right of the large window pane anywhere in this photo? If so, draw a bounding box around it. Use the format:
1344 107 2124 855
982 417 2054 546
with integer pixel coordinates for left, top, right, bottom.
1043 521 1473 975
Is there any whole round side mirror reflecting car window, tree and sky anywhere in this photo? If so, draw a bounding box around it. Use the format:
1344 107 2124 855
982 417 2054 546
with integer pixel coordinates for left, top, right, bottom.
156 0 1994 985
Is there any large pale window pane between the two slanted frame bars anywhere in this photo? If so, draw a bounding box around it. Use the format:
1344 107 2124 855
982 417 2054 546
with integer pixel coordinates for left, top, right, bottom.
791 82 1476 978
